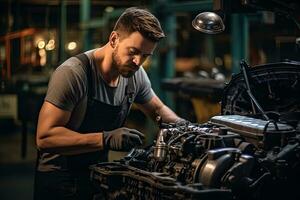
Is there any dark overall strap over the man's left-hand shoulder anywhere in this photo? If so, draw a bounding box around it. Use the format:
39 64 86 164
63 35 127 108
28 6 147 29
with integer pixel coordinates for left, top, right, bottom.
75 53 95 97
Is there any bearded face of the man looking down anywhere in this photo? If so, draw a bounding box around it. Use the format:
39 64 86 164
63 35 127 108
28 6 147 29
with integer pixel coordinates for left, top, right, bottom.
112 32 156 78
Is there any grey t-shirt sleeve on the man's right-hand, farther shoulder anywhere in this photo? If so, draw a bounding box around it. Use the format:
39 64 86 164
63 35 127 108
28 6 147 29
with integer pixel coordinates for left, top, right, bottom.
134 67 154 104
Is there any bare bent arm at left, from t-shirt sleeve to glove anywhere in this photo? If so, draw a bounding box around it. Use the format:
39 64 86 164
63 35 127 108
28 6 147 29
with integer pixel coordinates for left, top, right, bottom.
36 101 103 155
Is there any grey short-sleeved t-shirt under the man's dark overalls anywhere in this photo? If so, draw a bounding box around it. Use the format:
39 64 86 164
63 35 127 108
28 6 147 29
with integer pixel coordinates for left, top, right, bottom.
45 50 154 130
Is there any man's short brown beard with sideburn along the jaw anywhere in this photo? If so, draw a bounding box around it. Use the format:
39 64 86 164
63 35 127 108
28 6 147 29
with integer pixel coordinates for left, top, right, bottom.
112 46 138 78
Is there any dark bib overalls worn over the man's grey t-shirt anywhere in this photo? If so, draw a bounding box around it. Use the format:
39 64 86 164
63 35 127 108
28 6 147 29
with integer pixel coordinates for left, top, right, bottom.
34 54 135 200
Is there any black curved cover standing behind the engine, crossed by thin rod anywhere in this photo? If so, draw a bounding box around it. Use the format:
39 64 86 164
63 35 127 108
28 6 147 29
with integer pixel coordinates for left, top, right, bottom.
221 62 300 119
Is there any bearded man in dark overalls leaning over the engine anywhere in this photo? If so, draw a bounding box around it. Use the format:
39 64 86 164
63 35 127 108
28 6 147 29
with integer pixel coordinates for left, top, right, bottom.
35 8 183 200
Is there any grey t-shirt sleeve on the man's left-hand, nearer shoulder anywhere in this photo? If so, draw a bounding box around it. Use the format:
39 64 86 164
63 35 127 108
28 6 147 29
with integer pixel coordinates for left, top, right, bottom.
45 58 87 111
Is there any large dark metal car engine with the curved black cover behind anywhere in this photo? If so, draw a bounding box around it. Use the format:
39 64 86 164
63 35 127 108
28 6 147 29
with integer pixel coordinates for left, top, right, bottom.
91 62 300 200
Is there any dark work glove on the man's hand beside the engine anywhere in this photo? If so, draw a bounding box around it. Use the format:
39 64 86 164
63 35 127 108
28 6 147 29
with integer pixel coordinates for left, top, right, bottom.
103 127 145 151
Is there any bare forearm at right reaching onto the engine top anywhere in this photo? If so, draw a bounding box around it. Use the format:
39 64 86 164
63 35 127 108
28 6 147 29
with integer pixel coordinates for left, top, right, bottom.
137 95 180 123
